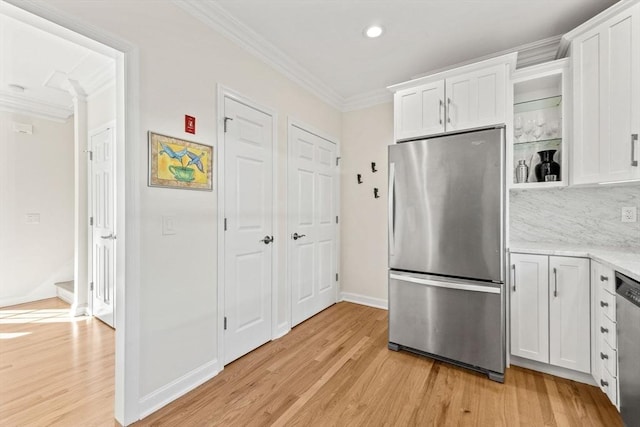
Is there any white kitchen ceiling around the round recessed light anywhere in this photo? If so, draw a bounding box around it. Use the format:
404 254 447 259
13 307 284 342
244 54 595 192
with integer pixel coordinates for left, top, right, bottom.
175 0 616 110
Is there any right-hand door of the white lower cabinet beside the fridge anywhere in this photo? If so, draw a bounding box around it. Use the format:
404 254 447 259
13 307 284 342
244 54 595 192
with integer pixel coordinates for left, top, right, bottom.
549 257 591 373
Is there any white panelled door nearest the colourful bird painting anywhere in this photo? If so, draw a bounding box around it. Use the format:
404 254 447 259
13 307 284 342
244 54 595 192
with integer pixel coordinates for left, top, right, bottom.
224 97 274 364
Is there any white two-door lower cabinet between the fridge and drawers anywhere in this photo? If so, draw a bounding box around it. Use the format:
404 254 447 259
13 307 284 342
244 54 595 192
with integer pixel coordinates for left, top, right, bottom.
510 253 591 373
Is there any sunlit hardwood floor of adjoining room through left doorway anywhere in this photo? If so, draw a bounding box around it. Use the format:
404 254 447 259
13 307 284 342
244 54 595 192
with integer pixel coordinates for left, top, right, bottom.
0 298 115 427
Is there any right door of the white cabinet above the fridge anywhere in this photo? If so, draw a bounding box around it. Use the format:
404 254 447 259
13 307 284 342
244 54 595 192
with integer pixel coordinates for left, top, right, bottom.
445 65 506 131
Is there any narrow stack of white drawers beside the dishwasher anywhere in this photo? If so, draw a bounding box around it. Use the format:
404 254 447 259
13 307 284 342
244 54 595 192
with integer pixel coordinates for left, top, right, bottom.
591 261 619 406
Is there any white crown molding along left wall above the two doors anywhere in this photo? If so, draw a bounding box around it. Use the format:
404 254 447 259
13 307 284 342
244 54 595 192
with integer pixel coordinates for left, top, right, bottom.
172 0 344 111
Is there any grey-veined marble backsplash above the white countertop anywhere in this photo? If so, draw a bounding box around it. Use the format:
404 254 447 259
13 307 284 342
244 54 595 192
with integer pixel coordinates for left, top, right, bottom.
509 184 640 251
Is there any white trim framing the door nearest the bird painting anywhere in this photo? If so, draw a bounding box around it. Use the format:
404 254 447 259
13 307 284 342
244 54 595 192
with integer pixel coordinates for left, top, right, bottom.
215 84 278 372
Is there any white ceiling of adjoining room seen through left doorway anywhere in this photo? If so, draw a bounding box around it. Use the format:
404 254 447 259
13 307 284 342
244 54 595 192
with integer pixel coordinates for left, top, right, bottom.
0 14 115 120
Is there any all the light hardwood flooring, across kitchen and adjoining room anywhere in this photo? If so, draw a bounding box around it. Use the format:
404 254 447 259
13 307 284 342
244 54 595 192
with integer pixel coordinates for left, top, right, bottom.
0 303 622 427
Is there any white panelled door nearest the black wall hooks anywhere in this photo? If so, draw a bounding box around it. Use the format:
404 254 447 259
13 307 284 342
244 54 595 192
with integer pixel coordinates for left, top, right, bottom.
288 125 338 326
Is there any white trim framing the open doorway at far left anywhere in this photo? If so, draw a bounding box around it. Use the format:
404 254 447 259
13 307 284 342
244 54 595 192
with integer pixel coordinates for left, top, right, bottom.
0 0 145 425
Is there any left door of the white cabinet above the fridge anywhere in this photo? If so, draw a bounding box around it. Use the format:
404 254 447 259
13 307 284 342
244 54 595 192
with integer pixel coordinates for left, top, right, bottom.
394 80 444 141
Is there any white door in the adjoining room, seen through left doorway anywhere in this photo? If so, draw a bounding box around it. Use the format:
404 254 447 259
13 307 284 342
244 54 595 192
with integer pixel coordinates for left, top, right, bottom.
89 128 116 328
